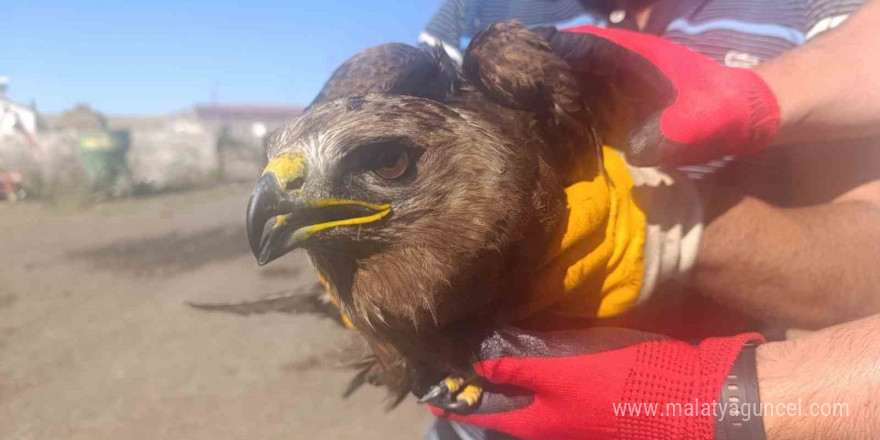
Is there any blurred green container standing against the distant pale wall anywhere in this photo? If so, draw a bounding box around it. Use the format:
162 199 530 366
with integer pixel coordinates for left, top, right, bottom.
79 131 131 191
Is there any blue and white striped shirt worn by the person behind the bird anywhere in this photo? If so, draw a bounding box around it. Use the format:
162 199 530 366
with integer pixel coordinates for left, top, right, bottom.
419 0 864 67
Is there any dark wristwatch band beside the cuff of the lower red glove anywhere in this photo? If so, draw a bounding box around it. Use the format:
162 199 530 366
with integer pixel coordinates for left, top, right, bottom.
715 342 767 440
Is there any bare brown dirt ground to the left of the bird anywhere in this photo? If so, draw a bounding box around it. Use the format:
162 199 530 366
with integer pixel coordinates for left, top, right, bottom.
0 185 430 440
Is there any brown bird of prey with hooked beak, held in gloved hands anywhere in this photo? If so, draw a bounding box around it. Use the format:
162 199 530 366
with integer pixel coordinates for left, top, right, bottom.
247 22 672 409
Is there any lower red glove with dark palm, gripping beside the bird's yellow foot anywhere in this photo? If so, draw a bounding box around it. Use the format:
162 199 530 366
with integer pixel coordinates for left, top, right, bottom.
432 327 763 440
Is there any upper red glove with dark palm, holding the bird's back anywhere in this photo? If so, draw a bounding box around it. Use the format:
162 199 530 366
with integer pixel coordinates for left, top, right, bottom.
536 26 780 166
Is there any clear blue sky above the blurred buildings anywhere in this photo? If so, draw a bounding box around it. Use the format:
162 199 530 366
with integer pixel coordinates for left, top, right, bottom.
6 0 441 115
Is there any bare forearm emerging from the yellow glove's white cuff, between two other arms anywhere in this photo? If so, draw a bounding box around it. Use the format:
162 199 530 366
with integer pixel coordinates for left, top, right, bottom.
691 176 880 328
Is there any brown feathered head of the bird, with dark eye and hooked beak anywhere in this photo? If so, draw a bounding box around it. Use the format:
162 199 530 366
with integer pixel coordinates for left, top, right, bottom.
247 94 552 344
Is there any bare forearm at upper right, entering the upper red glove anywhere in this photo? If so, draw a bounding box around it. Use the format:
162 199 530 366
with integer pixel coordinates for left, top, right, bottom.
755 1 880 148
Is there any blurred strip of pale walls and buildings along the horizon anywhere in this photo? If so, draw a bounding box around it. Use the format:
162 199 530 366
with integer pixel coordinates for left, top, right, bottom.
0 77 302 199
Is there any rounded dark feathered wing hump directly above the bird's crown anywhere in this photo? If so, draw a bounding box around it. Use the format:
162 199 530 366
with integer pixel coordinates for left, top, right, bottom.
312 43 458 105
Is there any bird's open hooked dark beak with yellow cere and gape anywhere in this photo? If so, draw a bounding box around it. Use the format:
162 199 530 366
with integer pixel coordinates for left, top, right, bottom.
247 152 391 266
